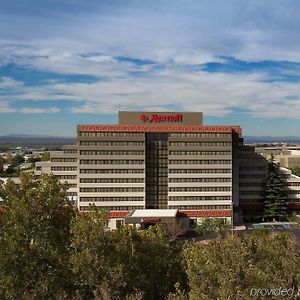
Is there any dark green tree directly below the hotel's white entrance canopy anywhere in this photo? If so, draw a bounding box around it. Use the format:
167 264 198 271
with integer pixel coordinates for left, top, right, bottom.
128 225 187 300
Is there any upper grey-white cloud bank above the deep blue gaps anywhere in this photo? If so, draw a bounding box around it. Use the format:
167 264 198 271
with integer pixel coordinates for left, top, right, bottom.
0 0 300 63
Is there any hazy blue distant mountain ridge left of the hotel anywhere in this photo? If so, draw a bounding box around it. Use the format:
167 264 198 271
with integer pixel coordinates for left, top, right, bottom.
0 134 75 146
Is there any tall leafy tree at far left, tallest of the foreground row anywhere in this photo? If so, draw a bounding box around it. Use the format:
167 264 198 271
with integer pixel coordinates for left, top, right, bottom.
0 172 74 299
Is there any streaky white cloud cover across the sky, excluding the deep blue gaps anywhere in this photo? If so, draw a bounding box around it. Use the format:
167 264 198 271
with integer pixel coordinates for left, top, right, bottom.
0 0 300 118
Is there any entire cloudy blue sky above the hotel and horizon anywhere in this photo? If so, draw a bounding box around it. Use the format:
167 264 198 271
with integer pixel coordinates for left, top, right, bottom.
0 0 300 136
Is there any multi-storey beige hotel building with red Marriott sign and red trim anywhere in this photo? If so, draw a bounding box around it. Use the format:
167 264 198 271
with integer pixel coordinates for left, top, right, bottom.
36 112 300 227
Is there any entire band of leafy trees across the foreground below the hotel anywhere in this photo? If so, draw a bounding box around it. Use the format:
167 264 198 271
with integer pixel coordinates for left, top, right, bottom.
0 173 300 300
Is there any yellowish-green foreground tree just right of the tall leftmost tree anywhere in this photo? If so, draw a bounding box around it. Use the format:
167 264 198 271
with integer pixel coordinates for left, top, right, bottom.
70 210 125 299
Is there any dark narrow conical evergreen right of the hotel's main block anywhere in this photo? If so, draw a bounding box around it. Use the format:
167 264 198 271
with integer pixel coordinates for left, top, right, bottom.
264 154 288 220
